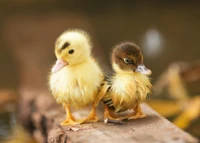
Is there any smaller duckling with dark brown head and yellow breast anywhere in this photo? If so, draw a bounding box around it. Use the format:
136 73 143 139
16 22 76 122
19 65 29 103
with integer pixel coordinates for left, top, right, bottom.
98 42 152 120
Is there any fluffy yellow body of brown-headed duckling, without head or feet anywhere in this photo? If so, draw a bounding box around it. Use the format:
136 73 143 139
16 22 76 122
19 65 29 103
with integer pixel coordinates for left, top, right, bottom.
110 73 152 112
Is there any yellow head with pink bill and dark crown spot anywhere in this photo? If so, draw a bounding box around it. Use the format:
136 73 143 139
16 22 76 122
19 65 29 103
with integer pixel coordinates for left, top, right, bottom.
52 29 91 73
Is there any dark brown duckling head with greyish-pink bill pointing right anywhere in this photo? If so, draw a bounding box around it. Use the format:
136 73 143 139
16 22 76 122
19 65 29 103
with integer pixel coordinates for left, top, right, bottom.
112 42 151 75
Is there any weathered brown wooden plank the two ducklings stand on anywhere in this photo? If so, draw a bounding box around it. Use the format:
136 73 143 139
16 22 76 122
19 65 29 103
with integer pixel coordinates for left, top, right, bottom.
19 90 198 143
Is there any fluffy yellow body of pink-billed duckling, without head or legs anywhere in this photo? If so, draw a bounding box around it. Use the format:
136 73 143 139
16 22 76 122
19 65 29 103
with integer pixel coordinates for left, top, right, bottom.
49 58 103 108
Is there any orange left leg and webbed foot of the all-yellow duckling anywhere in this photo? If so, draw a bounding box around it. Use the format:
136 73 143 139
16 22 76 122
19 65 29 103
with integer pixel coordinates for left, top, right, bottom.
61 105 81 125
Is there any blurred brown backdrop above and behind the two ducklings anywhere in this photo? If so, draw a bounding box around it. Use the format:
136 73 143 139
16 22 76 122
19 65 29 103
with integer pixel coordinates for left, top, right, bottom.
0 0 200 142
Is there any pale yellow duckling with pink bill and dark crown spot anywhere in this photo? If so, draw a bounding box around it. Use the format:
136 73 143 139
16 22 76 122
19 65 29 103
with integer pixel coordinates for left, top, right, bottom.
49 29 103 125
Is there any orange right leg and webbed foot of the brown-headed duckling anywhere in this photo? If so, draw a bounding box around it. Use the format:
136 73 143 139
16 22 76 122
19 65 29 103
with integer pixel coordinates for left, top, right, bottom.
127 104 146 120
